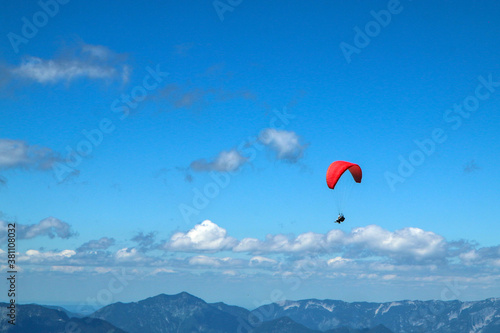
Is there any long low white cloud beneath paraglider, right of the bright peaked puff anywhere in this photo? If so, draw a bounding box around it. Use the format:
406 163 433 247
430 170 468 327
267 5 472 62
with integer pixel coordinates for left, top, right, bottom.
233 225 448 263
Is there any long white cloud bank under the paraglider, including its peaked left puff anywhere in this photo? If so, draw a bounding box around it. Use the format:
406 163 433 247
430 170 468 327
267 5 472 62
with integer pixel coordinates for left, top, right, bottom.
164 220 447 261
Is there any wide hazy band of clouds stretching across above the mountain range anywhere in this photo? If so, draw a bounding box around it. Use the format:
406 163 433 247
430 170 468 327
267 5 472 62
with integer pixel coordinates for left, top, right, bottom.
12 219 500 294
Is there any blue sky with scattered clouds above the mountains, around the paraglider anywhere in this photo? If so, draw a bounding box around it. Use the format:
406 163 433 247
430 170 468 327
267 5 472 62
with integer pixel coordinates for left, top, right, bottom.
0 0 500 308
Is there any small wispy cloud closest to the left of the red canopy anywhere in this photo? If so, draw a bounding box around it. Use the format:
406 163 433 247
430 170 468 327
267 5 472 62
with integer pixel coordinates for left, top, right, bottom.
259 128 307 163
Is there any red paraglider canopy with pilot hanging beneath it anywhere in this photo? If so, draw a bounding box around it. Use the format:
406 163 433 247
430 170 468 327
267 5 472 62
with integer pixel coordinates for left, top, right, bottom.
326 161 363 224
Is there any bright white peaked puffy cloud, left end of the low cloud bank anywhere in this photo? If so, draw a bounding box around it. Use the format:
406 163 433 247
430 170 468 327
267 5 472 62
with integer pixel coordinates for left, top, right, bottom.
164 220 237 252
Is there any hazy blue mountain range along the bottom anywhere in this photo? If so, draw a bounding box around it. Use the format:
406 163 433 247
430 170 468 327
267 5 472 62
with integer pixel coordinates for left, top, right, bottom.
0 292 500 333
